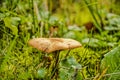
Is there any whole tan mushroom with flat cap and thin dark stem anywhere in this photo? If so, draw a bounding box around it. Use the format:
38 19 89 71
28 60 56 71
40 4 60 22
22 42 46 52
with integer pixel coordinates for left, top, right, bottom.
28 38 82 79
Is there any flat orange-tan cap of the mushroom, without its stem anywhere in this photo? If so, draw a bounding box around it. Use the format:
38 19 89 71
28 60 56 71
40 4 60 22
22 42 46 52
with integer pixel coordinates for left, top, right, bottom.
28 38 82 53
